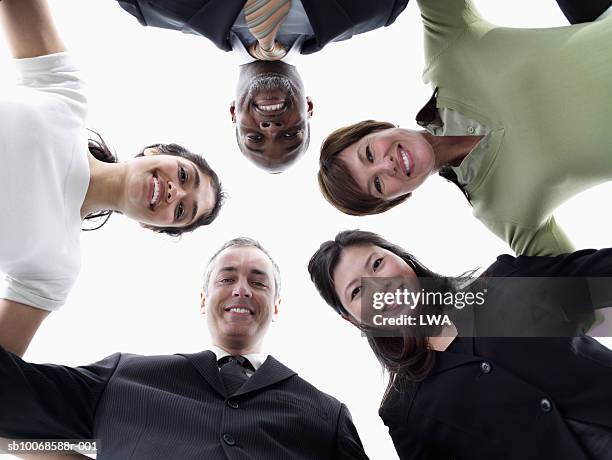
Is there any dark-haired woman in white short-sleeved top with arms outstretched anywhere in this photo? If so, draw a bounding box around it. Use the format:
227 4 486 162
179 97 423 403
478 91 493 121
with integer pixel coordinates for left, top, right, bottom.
0 0 223 354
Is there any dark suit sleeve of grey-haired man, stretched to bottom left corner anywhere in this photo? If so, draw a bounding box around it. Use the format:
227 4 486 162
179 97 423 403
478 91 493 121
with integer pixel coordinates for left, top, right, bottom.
0 347 121 439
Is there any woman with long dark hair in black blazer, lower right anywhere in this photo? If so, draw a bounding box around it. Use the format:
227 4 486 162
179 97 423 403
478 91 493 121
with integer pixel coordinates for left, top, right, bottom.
308 230 612 460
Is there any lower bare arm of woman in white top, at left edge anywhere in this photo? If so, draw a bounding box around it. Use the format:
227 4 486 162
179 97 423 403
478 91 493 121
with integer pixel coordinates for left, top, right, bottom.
0 299 49 356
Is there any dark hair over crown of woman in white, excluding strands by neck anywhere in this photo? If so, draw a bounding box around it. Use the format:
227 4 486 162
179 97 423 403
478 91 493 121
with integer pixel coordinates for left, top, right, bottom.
136 144 225 236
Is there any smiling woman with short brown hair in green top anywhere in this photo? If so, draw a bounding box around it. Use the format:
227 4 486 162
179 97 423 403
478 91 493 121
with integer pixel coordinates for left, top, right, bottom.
319 0 612 255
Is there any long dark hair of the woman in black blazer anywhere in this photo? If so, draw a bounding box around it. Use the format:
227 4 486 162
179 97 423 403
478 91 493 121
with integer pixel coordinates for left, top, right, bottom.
308 230 474 401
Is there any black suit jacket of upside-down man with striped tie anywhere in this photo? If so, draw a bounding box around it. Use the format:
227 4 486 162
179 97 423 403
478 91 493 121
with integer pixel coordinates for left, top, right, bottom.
118 0 408 54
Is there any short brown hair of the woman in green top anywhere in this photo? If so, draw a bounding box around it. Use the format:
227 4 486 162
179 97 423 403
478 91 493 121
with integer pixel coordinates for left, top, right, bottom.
317 120 410 216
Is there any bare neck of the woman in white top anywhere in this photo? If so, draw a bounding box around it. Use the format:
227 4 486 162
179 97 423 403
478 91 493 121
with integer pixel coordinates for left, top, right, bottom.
81 154 126 218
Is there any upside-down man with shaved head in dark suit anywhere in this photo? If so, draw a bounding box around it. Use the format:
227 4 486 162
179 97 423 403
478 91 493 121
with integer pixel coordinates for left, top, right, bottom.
118 0 408 172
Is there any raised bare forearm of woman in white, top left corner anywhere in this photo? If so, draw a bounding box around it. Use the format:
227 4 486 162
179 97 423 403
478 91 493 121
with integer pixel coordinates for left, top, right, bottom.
0 0 66 58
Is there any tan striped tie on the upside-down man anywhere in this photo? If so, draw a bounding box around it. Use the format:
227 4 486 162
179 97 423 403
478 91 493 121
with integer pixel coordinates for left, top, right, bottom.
242 0 291 61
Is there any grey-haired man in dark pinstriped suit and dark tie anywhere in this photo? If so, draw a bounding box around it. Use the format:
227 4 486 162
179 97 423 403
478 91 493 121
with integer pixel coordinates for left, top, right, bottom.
0 238 367 460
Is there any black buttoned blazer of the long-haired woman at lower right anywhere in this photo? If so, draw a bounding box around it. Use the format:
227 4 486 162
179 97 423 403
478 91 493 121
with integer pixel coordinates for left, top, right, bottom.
379 249 612 460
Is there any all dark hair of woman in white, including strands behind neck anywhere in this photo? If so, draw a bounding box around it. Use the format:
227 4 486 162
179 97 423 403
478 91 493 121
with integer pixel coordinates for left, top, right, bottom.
83 130 225 236
